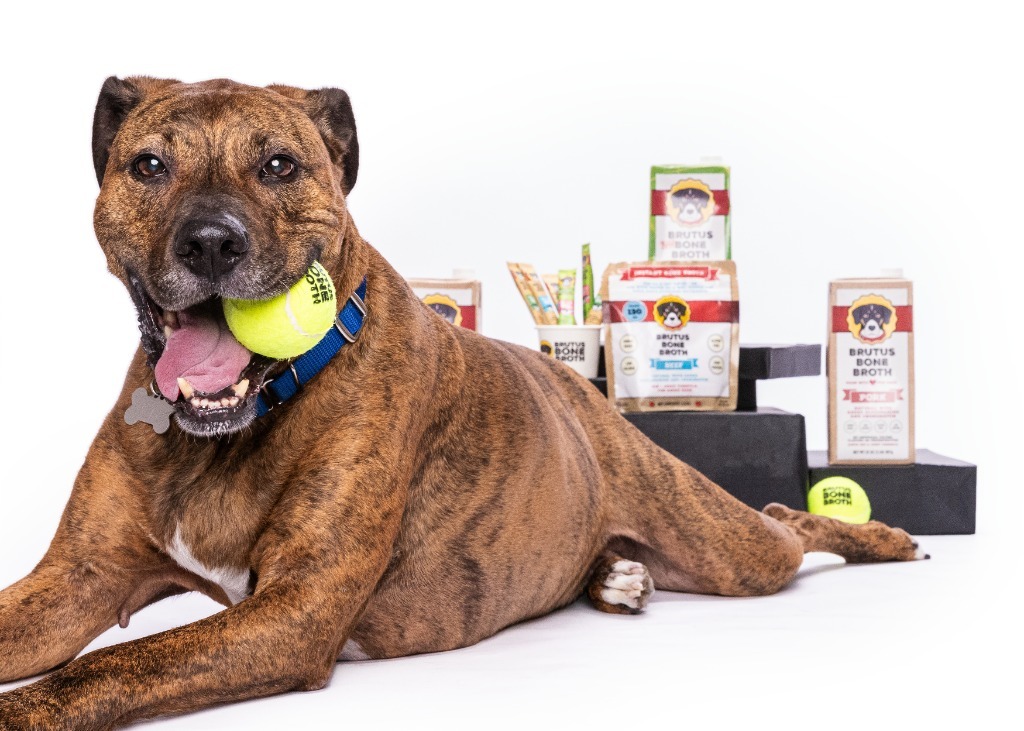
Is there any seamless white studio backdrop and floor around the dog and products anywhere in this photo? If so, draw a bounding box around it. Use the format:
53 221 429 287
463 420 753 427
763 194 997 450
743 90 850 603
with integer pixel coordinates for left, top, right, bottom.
0 0 1024 729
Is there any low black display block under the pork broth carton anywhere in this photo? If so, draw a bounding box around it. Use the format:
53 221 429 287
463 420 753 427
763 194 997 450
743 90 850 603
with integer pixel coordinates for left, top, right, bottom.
808 449 978 535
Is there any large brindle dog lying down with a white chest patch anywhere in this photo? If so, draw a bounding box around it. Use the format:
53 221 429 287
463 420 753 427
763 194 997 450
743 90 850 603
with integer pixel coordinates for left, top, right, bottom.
0 78 916 729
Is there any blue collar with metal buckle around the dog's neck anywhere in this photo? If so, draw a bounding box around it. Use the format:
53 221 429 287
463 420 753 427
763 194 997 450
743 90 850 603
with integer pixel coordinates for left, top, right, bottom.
256 277 367 417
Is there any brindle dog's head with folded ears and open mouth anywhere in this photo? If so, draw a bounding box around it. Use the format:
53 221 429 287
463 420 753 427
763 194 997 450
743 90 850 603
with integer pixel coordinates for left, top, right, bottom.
92 77 358 436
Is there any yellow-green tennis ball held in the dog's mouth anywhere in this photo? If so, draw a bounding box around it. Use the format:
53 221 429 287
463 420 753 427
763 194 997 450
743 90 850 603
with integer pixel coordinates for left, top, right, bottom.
224 261 337 358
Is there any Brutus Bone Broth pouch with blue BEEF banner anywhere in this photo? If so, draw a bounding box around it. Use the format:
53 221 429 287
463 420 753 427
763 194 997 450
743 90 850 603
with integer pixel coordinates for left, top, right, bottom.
601 261 739 412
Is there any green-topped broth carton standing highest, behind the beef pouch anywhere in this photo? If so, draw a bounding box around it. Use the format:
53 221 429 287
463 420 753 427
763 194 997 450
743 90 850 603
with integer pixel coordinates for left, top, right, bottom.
649 165 732 262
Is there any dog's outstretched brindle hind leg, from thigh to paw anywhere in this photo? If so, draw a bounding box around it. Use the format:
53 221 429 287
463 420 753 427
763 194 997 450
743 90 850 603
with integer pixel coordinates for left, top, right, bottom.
602 435 916 596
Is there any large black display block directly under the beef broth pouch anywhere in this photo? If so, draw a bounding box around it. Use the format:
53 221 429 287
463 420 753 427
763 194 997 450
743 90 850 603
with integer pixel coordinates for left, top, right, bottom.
623 409 807 510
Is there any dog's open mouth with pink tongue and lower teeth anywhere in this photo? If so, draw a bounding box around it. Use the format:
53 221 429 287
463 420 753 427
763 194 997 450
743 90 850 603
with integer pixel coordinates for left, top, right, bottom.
129 277 280 435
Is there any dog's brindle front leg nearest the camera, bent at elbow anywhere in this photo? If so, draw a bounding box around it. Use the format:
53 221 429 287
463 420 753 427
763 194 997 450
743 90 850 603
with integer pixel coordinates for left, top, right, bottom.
0 464 404 730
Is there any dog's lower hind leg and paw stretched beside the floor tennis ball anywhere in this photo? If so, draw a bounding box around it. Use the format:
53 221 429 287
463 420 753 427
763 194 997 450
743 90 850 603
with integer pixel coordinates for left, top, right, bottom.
764 503 931 563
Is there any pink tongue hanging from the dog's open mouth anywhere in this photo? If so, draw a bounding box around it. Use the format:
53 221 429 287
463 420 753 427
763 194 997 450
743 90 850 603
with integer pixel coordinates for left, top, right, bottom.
155 311 252 401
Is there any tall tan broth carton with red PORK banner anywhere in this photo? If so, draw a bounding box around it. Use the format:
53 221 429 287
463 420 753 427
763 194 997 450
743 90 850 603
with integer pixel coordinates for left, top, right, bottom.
827 278 914 465
